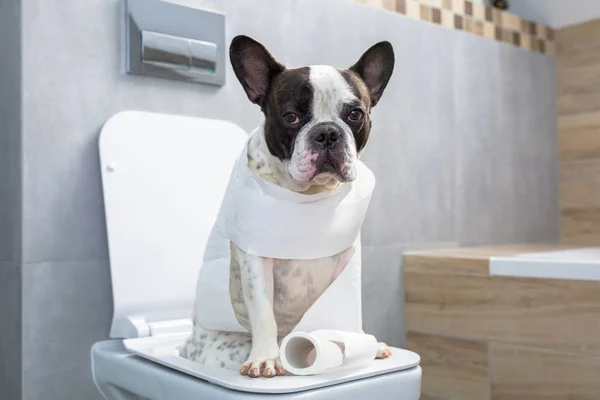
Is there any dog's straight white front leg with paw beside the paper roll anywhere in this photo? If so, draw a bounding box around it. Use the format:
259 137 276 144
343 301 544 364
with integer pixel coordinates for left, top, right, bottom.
233 246 285 378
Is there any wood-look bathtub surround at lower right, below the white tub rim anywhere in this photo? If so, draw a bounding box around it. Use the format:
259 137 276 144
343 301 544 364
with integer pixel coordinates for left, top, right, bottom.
404 244 600 400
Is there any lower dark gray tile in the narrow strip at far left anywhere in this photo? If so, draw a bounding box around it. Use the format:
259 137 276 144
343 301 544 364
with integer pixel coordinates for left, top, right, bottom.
0 262 22 400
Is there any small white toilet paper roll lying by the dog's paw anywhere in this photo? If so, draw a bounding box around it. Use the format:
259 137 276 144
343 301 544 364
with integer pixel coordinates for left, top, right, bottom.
280 330 379 375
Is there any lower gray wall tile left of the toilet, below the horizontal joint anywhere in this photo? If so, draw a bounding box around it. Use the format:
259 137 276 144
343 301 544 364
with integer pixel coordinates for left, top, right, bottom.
23 261 112 400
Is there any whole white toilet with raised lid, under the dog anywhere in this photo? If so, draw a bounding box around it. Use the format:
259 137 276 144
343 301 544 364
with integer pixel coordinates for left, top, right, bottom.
91 111 421 400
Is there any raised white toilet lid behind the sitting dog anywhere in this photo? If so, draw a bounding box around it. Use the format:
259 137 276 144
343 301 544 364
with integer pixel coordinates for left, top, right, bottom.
99 111 248 338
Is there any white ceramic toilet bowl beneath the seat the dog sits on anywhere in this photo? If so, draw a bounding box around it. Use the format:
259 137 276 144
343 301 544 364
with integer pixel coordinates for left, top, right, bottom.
92 340 421 400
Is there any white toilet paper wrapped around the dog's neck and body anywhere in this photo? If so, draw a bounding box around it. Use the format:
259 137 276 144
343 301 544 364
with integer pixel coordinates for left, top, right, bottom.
195 133 375 333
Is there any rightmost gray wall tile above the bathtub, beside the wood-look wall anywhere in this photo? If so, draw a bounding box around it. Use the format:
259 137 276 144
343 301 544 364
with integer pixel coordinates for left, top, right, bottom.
455 38 559 245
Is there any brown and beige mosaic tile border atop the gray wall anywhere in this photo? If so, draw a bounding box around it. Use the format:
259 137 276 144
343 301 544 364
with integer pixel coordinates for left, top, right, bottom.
354 0 555 55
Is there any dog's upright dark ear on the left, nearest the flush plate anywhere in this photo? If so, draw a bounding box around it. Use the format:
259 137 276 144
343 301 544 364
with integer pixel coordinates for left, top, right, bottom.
229 35 285 108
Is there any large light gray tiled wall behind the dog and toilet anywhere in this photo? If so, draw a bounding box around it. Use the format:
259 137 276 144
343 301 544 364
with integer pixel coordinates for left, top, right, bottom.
0 0 558 399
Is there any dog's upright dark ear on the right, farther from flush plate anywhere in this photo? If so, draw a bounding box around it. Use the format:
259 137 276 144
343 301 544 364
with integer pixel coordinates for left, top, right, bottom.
350 42 394 107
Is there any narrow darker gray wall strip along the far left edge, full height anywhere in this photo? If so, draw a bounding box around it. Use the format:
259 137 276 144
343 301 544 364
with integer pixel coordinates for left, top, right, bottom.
0 0 21 399
